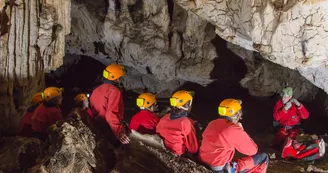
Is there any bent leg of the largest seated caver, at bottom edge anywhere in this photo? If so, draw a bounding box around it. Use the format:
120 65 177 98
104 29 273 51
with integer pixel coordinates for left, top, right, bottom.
237 153 269 173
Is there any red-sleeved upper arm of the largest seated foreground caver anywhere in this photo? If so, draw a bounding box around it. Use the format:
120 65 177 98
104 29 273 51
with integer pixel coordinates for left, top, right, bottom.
229 126 258 156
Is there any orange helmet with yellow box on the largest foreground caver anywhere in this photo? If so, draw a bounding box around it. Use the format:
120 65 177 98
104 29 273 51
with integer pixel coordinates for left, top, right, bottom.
218 99 242 117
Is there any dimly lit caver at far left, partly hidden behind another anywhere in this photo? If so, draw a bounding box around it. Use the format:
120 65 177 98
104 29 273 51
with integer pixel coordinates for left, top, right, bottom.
17 92 43 137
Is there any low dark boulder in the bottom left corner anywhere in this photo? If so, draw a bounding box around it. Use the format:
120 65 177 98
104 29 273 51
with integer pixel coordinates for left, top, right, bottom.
0 137 42 173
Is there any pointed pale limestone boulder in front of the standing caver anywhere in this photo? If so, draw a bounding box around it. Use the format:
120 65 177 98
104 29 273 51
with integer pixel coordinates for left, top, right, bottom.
29 111 115 173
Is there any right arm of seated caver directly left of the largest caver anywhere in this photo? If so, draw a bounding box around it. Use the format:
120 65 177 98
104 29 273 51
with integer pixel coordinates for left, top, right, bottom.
182 119 199 154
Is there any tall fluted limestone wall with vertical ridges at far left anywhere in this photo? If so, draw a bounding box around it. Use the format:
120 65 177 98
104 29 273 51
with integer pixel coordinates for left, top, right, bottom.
0 0 71 130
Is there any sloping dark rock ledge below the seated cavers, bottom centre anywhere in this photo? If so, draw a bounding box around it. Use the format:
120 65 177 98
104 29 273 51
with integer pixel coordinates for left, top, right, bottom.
111 131 212 173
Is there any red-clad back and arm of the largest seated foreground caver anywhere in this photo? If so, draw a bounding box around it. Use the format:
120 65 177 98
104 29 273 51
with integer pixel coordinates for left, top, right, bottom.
199 118 257 166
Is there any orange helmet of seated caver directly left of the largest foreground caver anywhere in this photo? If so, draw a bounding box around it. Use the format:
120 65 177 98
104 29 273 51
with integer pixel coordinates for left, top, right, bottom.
170 90 194 109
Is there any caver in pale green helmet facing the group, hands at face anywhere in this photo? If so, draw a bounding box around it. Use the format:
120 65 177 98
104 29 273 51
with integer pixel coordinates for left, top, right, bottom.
272 87 309 146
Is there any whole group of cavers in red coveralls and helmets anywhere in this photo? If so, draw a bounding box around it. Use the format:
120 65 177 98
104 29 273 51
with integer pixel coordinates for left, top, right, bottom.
18 64 322 173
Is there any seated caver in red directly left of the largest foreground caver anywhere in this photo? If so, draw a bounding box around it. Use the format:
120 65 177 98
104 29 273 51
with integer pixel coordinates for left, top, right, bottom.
156 90 199 156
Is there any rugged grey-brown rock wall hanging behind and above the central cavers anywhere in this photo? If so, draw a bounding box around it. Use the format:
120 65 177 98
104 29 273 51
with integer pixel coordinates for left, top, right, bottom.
66 0 217 95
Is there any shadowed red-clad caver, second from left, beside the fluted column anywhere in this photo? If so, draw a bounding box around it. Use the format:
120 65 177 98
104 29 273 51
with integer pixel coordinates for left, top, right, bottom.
32 87 63 140
